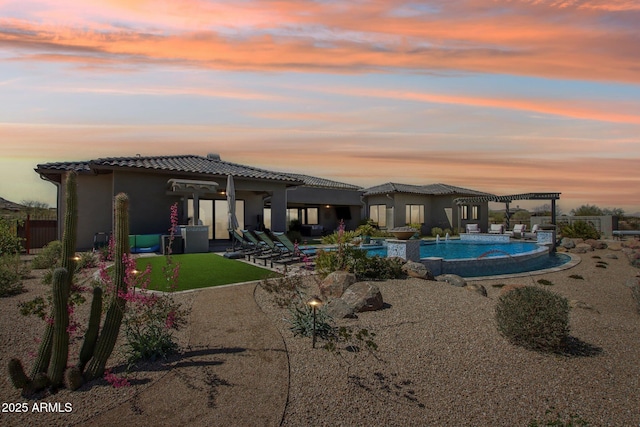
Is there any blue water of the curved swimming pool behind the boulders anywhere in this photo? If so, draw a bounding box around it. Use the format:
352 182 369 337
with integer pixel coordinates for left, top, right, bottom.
367 240 572 277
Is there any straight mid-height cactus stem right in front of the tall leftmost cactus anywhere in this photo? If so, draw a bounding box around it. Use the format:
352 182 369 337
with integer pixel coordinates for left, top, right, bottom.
47 268 69 388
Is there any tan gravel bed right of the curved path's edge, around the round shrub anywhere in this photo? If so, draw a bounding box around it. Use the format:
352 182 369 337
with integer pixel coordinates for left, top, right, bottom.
257 246 640 426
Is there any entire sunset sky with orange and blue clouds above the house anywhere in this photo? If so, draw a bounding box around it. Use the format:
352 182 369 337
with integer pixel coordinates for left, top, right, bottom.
0 0 640 213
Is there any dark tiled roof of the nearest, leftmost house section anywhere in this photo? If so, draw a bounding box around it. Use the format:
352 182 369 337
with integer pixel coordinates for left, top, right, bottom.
36 155 300 184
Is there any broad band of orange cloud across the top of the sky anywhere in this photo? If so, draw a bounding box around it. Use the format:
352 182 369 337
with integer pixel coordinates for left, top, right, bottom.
0 0 640 83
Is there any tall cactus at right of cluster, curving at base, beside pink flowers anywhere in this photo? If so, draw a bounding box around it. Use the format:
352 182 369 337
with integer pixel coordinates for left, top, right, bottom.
84 193 129 380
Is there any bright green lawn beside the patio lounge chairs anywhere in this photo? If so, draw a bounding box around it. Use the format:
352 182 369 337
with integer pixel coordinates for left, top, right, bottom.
136 253 275 291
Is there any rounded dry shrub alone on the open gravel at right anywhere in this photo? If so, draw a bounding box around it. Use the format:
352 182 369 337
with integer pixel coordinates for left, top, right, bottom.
496 286 569 351
